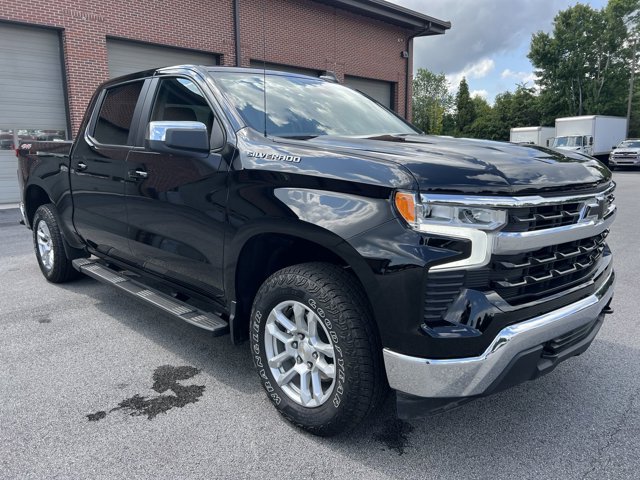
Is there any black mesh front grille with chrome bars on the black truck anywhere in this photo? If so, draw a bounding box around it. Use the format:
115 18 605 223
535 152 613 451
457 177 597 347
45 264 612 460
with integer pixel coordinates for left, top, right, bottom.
424 183 616 312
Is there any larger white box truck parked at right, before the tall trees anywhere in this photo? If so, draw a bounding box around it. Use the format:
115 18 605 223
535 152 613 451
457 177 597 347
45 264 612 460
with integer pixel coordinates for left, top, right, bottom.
553 115 627 162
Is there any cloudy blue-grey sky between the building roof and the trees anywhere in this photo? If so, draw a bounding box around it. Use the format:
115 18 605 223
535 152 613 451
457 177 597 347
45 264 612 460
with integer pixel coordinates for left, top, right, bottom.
390 0 607 102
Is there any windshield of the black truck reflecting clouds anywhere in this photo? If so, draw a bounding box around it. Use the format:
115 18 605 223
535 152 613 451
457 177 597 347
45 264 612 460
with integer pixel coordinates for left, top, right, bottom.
213 72 418 138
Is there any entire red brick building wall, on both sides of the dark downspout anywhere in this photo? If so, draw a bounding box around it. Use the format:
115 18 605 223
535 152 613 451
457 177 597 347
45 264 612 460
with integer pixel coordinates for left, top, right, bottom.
0 0 407 135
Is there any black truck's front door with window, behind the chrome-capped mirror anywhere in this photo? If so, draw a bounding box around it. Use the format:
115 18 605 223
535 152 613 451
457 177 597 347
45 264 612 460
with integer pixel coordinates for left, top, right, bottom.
126 77 227 300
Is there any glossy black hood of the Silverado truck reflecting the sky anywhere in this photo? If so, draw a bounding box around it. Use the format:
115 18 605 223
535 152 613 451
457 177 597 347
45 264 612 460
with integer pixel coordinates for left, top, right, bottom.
304 135 611 194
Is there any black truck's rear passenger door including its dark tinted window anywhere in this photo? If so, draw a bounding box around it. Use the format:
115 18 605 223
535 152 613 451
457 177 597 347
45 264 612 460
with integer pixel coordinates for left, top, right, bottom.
70 80 149 260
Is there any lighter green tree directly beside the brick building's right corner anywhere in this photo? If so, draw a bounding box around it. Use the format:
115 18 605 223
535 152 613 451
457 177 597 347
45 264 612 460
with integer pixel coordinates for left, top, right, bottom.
413 68 453 135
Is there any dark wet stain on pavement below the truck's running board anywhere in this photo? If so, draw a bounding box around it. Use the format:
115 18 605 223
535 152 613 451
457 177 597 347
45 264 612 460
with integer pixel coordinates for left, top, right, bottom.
87 365 204 421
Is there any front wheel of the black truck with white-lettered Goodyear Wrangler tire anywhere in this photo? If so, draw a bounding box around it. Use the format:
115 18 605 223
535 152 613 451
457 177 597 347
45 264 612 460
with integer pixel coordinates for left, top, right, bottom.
251 263 387 436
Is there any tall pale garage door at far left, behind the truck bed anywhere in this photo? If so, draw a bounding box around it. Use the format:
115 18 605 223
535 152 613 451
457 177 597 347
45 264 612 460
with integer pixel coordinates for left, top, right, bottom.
0 23 67 204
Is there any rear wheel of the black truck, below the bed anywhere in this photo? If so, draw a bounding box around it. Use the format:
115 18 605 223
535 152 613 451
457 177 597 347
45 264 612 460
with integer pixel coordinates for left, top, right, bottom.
33 203 83 283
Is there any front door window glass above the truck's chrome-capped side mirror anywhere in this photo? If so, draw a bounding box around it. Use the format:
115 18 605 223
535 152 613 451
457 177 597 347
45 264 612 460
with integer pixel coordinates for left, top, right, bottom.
151 78 214 136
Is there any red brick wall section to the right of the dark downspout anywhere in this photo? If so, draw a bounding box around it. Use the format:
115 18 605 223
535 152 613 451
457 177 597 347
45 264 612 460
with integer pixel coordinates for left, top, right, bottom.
240 0 408 115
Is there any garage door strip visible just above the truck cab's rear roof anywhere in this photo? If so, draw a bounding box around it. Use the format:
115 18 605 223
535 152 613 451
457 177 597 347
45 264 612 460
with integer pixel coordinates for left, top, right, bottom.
107 39 219 78
